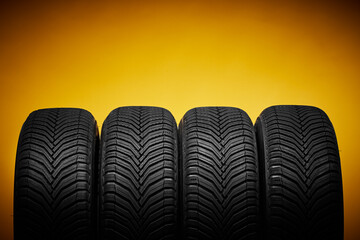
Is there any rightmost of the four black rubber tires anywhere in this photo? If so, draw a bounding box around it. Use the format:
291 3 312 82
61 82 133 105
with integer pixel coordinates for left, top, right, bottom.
255 106 344 240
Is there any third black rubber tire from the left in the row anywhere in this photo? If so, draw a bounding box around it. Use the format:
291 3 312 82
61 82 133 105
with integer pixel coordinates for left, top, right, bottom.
179 107 259 240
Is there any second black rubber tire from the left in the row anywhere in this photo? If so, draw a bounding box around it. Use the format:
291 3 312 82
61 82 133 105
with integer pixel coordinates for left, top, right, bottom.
99 107 178 240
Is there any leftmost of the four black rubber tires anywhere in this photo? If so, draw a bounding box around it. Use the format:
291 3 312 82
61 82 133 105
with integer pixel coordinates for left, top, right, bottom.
14 108 98 240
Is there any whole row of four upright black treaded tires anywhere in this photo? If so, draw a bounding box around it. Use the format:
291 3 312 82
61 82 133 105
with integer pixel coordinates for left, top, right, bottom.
14 105 343 240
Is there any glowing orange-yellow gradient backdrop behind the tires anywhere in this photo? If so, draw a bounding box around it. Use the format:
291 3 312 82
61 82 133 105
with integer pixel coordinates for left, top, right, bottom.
0 0 360 240
